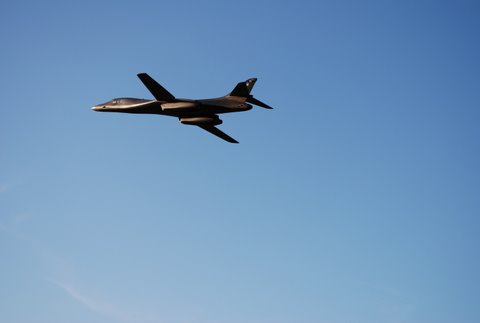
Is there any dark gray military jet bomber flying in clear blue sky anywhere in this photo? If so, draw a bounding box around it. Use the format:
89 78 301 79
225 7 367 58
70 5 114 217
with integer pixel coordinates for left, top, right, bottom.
92 73 272 143
